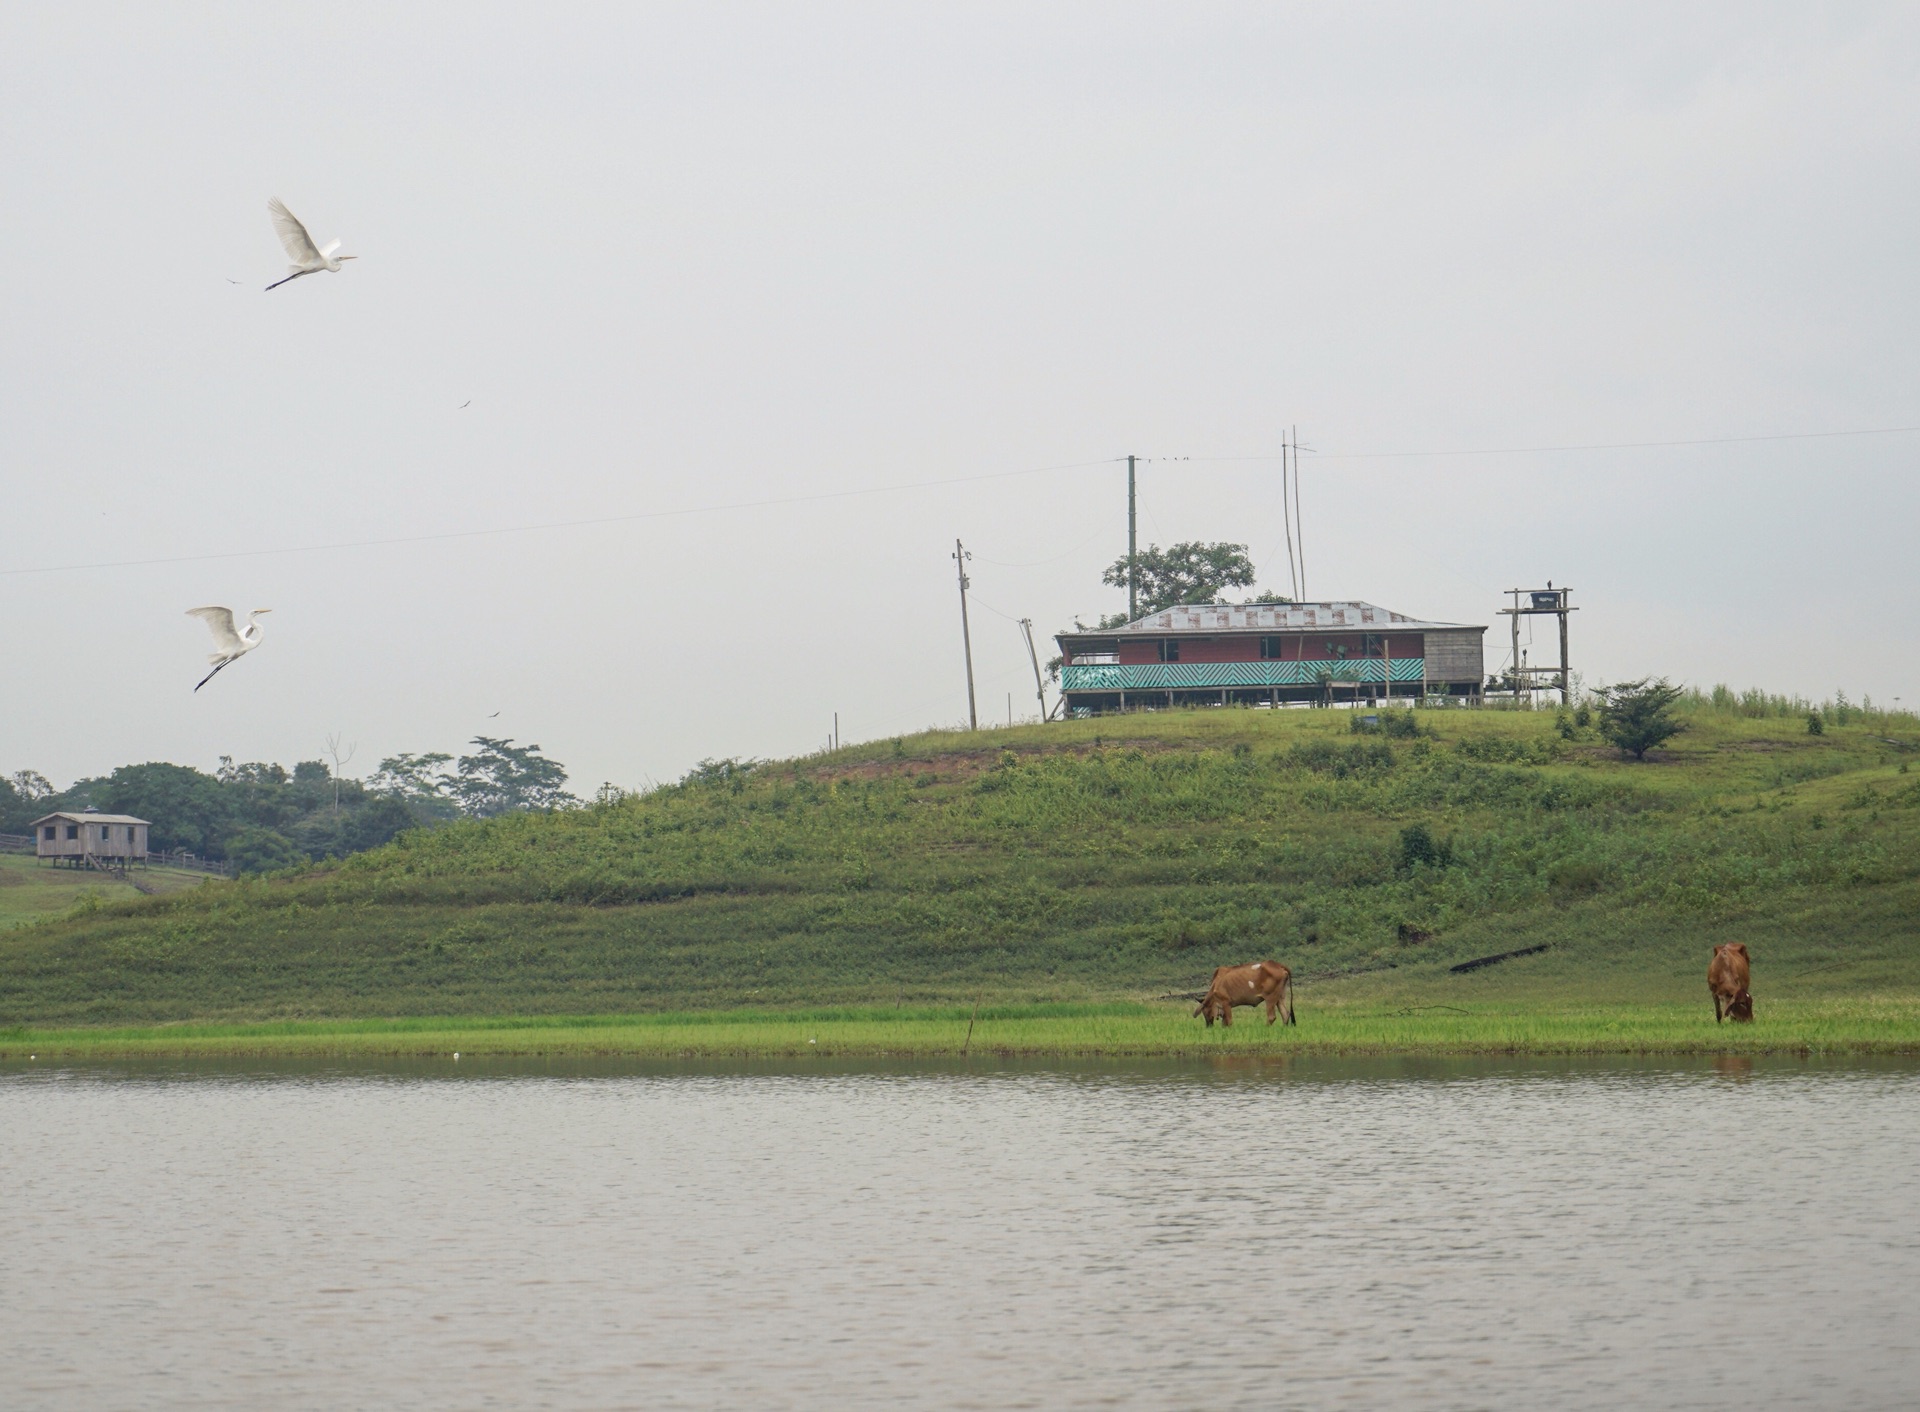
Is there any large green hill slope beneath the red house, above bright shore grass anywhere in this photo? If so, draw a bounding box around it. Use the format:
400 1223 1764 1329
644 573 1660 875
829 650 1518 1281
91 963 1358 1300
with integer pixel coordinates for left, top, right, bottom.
0 705 1920 1026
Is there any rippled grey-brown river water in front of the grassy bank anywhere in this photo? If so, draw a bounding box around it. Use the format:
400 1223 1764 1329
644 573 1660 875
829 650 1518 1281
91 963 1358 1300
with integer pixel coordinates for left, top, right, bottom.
0 1060 1920 1408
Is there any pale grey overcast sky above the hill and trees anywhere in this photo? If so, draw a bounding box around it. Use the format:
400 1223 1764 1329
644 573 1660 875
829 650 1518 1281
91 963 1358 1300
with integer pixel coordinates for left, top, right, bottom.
0 0 1920 793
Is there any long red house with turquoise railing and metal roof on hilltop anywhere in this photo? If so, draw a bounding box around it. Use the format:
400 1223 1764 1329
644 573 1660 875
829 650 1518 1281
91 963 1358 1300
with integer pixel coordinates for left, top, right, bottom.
1054 603 1486 715
